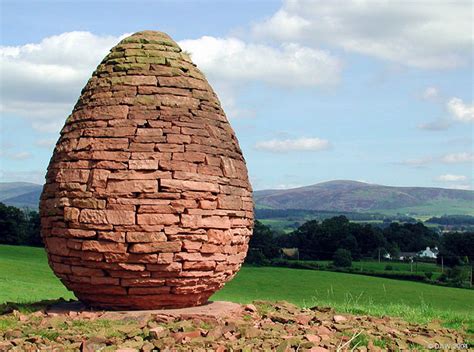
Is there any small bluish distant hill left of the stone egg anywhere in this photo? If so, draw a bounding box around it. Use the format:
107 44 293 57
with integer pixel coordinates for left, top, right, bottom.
0 182 43 209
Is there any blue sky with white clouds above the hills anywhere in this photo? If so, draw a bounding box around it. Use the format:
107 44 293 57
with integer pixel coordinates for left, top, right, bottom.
0 0 474 190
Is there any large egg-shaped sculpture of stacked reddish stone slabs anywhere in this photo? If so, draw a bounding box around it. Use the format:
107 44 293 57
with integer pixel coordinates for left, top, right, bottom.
40 31 253 309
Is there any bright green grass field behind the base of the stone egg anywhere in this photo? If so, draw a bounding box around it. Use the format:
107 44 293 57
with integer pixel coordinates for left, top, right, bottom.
0 246 474 329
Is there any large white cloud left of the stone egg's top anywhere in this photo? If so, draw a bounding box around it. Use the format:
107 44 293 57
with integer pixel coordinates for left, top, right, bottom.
0 32 125 132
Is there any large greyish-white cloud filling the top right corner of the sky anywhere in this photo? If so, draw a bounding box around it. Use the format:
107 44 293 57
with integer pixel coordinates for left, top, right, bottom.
253 0 472 69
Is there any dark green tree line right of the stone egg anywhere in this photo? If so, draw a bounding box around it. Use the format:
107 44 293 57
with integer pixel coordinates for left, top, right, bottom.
247 216 474 266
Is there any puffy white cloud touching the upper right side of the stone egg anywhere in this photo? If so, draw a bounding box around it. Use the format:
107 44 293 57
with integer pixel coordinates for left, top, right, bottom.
178 36 341 87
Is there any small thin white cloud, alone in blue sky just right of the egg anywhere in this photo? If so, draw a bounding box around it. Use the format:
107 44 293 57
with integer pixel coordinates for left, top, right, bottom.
255 138 331 152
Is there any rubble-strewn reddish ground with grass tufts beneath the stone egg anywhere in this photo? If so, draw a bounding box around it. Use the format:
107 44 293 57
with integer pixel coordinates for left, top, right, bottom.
0 301 472 352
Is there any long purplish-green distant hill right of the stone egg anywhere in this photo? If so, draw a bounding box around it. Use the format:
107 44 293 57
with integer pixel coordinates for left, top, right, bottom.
254 180 474 215
